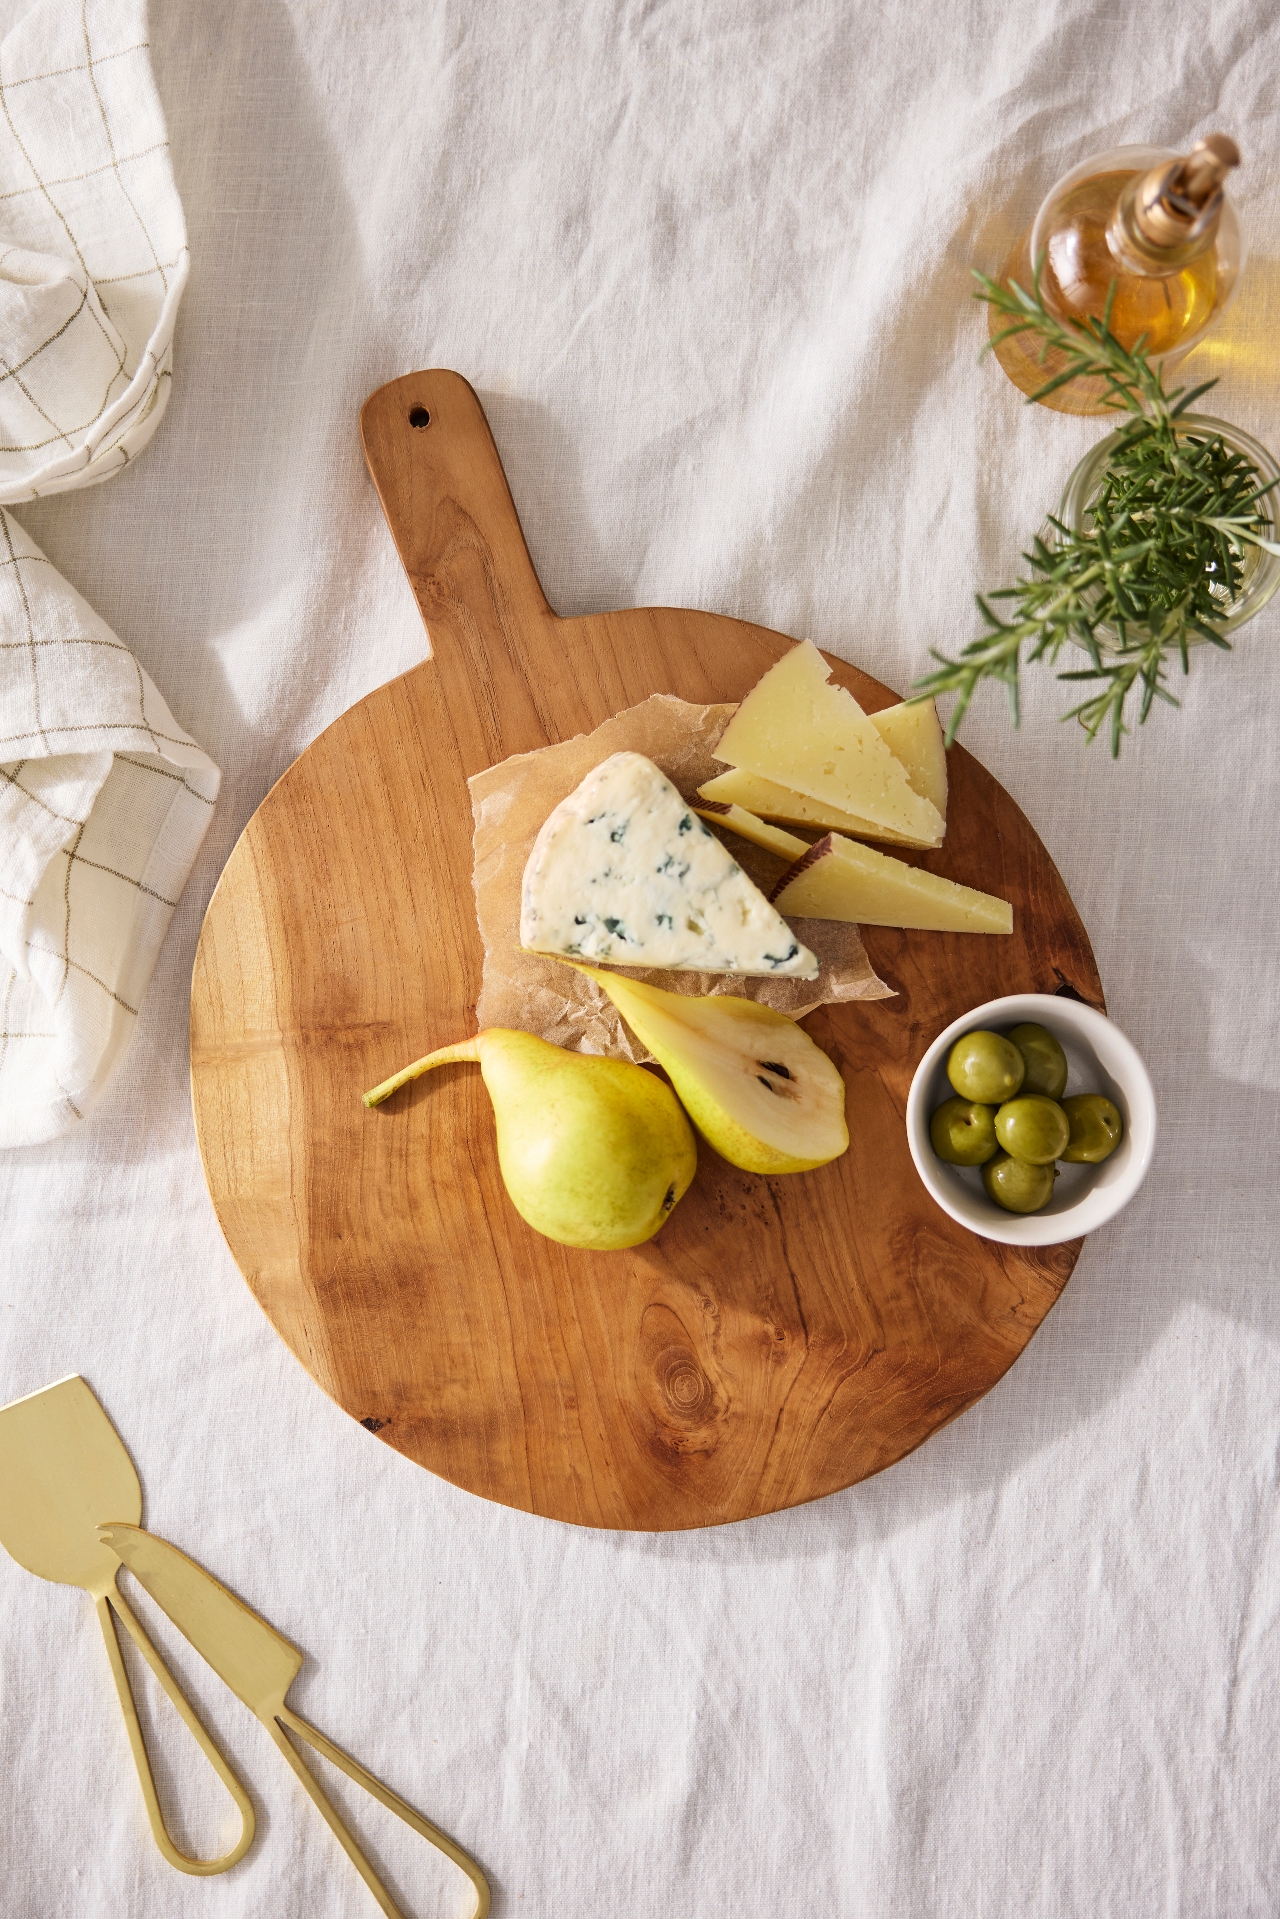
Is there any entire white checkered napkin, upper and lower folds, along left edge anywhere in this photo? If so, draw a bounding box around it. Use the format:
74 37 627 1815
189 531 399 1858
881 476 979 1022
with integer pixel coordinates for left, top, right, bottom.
0 0 219 1146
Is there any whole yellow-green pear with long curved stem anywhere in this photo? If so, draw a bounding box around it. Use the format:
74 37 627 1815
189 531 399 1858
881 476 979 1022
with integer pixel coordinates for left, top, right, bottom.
365 1027 699 1253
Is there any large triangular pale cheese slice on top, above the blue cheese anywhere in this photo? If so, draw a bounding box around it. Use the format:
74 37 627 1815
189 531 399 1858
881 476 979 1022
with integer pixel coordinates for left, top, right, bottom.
716 639 946 844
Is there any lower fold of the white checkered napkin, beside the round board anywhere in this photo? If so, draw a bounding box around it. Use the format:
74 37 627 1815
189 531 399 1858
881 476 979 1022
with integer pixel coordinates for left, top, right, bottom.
0 510 219 1146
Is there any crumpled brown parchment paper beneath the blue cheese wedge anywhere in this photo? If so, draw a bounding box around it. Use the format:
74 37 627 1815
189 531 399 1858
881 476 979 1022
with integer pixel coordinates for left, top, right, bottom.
468 693 892 1061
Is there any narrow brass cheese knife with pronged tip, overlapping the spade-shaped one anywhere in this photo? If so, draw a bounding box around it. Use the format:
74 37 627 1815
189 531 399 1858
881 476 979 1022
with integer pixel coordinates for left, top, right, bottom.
98 1522 489 1919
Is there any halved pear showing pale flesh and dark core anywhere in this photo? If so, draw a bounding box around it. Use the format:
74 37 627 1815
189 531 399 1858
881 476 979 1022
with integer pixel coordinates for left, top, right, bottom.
578 965 848 1173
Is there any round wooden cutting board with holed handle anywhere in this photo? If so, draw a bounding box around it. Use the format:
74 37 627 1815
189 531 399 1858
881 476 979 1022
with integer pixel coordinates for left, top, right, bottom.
192 372 1103 1531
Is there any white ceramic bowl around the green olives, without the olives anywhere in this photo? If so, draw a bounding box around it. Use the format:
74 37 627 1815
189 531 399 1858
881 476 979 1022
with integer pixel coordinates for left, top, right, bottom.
906 992 1155 1245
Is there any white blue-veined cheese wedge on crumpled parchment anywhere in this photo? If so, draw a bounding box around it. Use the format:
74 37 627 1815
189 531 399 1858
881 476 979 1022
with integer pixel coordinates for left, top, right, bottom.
520 752 818 979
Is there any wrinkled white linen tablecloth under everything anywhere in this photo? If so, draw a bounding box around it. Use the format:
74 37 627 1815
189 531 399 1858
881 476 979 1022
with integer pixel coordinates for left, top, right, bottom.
0 0 1280 1919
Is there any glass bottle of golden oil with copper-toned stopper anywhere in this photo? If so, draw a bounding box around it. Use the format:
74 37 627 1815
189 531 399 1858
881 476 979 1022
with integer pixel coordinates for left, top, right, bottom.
988 132 1244 413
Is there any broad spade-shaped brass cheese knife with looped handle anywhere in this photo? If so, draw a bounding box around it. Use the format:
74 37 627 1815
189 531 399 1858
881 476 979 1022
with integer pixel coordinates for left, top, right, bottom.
0 1374 253 1873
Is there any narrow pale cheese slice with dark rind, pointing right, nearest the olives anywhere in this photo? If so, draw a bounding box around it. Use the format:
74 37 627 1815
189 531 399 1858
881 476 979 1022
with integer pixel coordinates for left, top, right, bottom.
773 833 1013 933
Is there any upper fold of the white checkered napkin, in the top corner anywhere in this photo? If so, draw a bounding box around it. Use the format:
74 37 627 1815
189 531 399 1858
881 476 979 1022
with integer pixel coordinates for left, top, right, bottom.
0 0 188 505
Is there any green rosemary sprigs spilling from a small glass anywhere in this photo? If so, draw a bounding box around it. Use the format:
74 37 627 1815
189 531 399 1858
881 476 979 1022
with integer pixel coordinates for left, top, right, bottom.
915 267 1280 756
